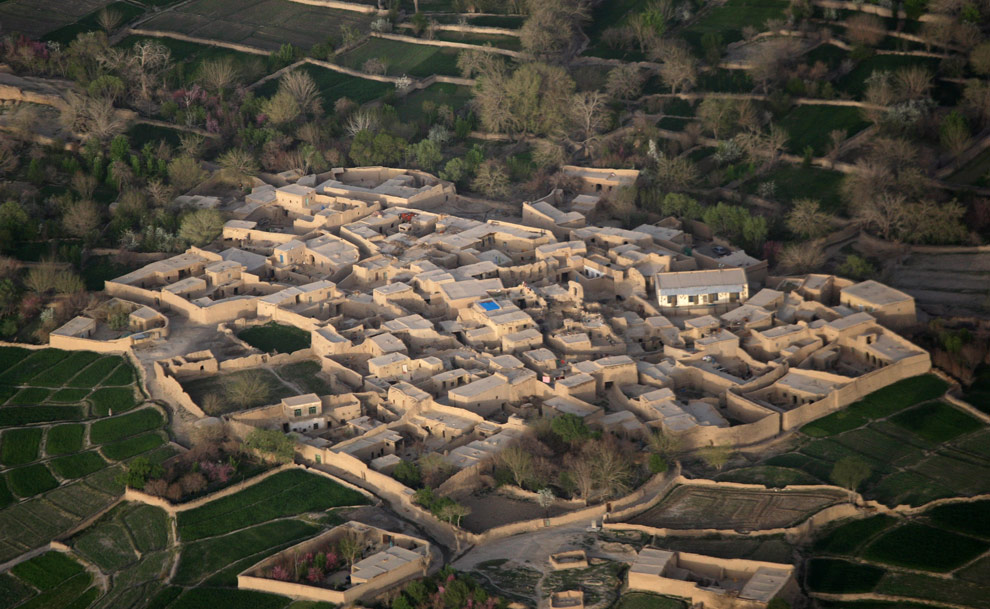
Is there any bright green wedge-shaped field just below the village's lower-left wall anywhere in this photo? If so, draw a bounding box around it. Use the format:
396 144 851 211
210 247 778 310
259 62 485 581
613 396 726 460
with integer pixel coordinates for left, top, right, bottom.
178 469 367 542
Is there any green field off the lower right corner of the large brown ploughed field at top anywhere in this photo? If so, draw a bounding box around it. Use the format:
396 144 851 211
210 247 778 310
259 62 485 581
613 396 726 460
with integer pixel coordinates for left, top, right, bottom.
336 38 460 78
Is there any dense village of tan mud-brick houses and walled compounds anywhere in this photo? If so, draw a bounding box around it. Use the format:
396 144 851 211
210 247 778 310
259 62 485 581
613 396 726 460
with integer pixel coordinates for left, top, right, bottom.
29 167 944 607
